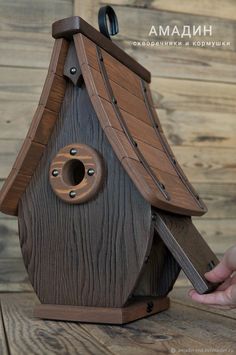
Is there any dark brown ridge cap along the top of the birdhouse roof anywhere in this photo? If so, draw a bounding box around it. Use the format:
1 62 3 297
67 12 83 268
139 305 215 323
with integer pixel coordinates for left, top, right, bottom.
52 16 151 83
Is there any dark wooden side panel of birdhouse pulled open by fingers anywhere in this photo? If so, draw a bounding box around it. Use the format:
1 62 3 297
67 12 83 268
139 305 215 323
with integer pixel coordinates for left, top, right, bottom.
153 209 219 294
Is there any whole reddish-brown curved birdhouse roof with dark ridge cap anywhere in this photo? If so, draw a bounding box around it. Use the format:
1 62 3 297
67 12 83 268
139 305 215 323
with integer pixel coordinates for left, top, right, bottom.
0 17 207 215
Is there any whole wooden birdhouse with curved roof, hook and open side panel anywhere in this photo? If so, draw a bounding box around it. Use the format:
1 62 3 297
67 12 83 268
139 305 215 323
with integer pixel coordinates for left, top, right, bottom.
0 6 218 324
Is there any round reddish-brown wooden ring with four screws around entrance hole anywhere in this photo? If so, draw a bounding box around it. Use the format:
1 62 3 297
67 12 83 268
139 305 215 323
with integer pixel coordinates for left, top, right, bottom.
49 144 104 204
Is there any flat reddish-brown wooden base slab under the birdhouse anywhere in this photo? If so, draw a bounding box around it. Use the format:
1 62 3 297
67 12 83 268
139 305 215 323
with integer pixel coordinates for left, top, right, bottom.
34 297 170 324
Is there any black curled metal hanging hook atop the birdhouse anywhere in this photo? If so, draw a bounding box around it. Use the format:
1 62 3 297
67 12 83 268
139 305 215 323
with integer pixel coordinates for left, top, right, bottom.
98 5 119 39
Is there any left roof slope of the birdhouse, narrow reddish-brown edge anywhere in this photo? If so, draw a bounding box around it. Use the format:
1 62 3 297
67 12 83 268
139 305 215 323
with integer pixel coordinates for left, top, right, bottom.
0 39 68 215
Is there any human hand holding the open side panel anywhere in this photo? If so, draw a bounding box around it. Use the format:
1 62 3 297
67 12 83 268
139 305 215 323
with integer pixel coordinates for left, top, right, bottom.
188 246 236 308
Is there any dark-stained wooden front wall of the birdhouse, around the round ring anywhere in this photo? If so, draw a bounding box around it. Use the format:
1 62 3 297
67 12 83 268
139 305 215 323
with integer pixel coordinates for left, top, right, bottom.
18 82 157 307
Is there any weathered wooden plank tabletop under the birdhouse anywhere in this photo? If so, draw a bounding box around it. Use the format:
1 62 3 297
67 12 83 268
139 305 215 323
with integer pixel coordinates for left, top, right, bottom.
0 288 236 355
